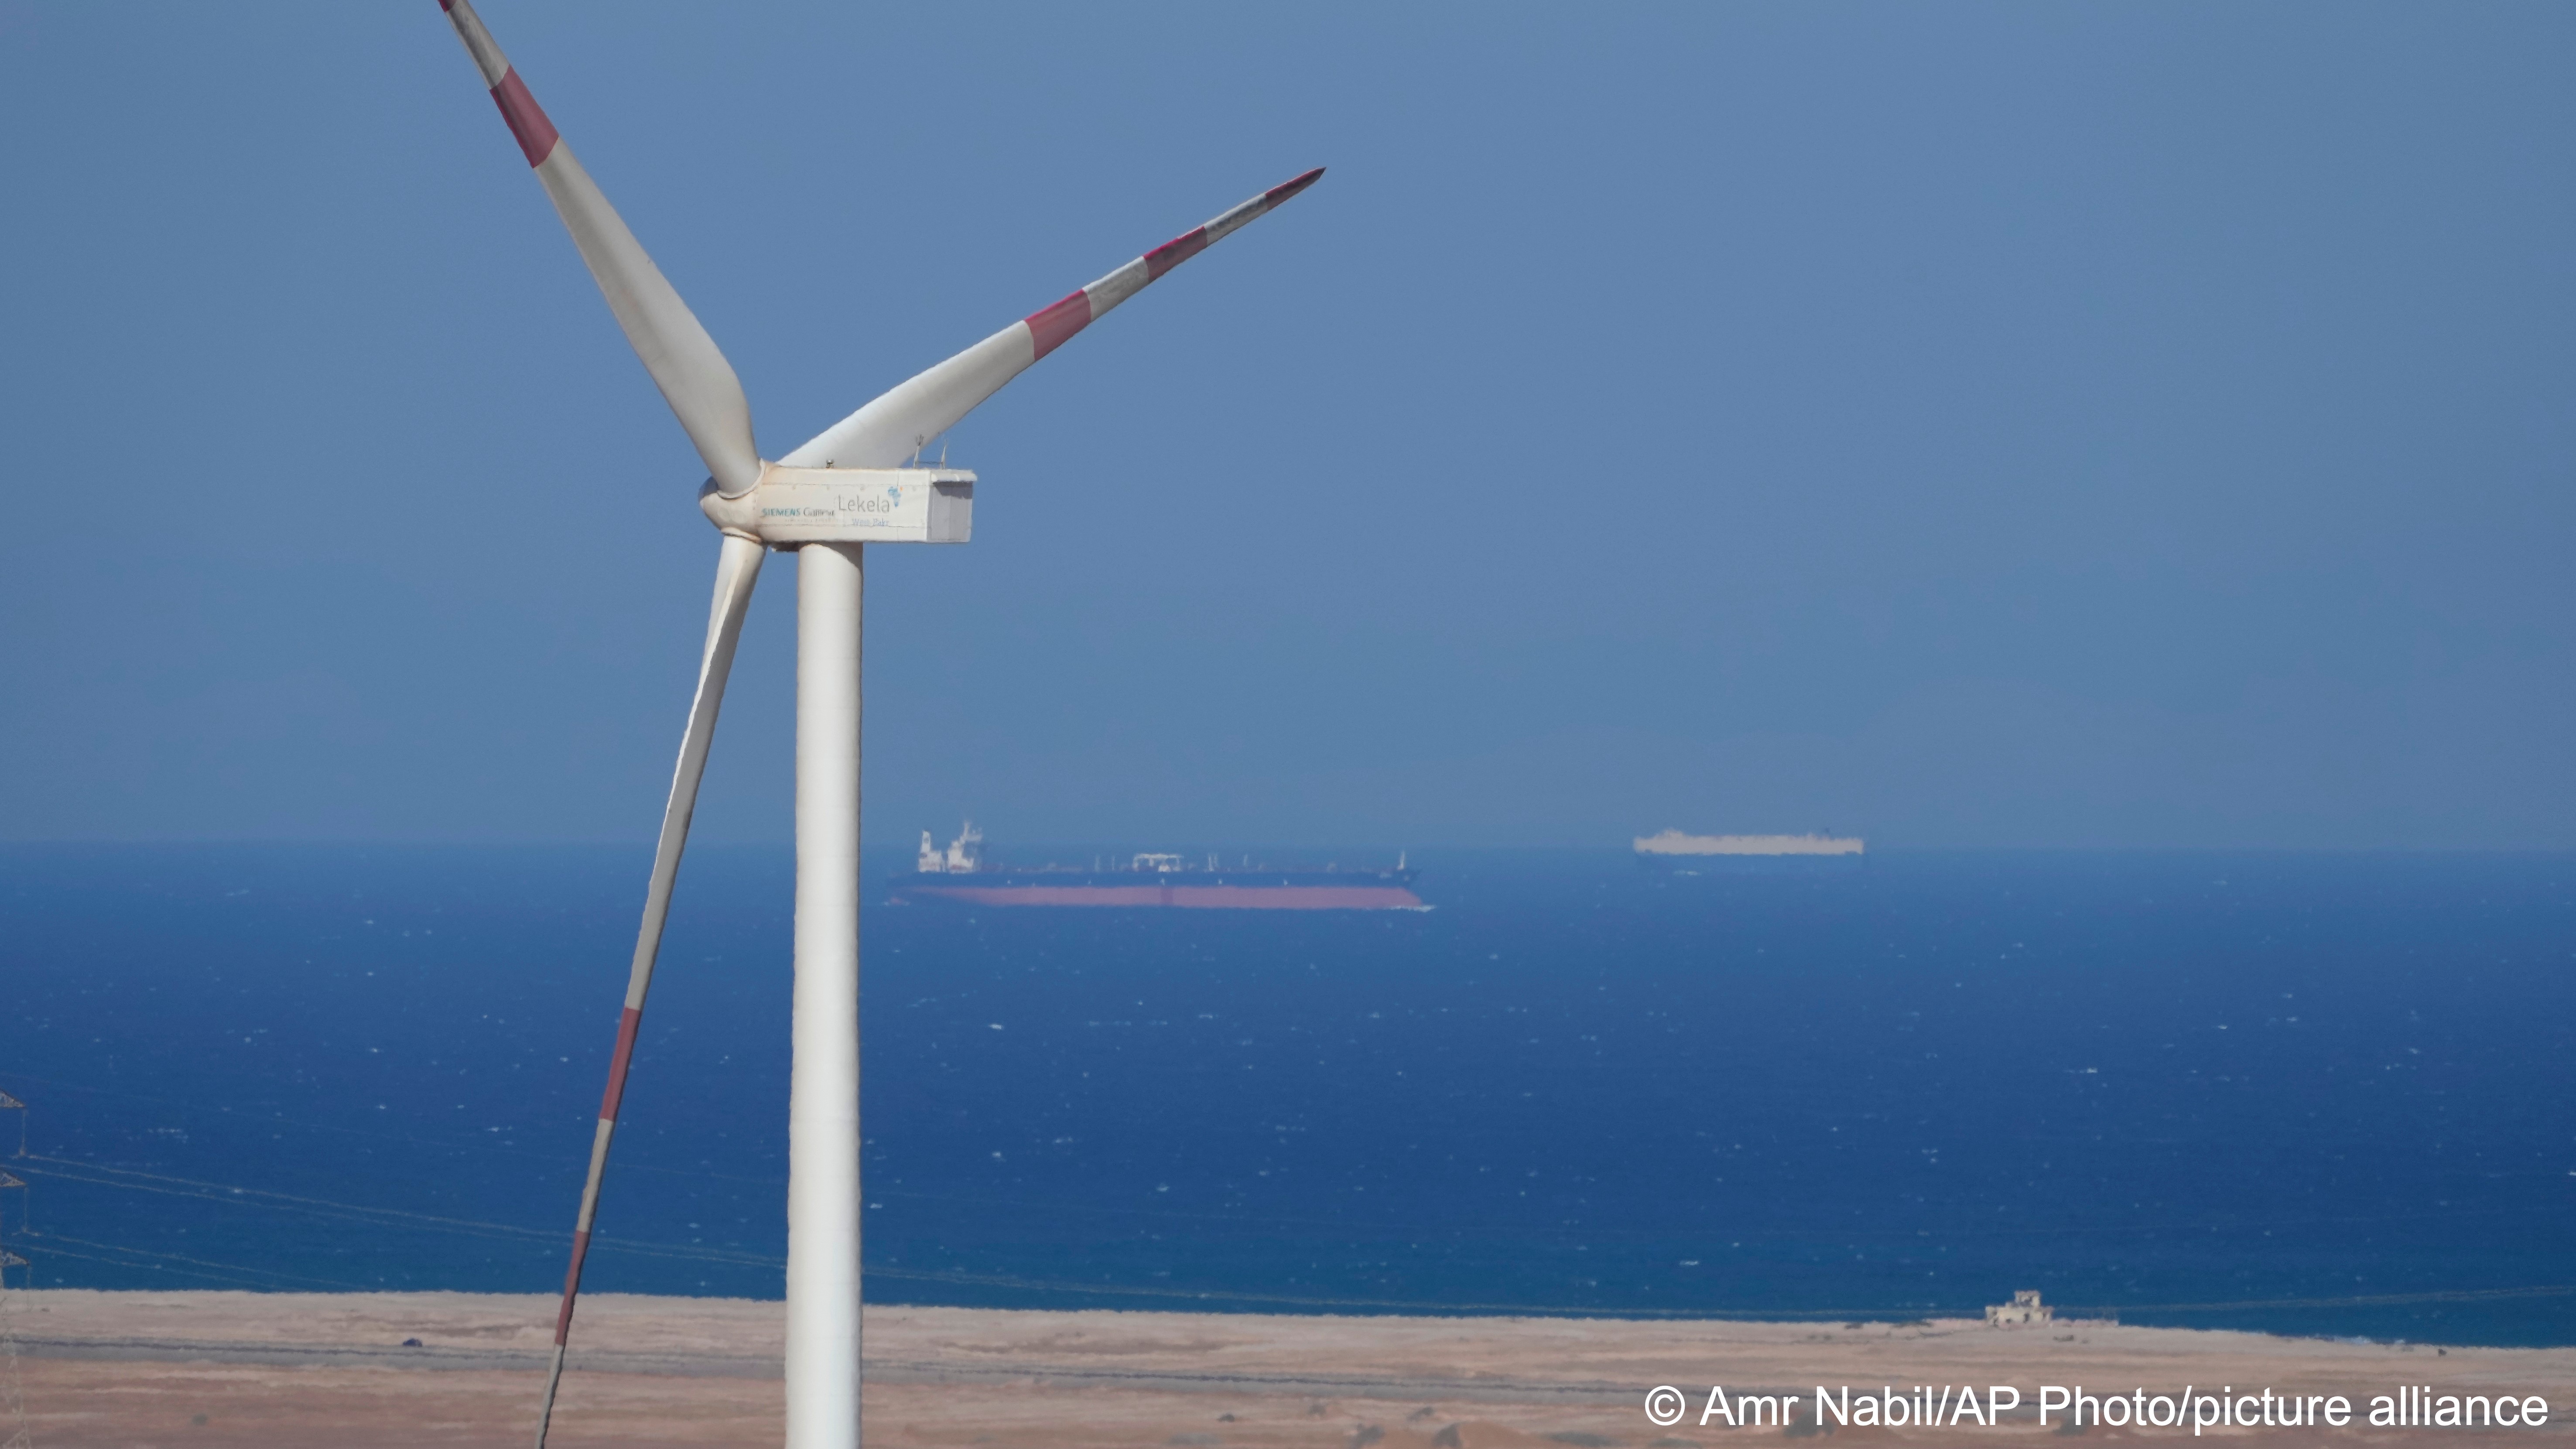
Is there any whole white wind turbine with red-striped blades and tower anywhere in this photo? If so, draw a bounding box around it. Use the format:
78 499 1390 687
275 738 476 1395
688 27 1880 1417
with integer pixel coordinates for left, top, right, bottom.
438 0 1324 1449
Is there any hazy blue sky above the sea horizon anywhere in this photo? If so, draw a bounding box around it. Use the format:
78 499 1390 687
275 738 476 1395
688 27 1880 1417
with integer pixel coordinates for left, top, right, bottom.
0 0 2576 847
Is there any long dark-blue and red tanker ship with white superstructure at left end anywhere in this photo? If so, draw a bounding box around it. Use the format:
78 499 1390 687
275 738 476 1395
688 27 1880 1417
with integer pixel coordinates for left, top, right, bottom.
891 821 1430 911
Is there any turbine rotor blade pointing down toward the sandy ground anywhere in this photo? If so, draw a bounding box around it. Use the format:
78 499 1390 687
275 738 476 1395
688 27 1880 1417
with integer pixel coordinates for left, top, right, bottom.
536 533 763 1449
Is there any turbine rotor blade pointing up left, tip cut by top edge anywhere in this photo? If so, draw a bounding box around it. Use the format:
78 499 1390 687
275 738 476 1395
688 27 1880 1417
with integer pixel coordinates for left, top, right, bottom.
438 0 760 497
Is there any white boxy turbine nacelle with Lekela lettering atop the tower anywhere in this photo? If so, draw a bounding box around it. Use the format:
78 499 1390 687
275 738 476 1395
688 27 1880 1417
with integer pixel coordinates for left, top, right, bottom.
698 463 974 548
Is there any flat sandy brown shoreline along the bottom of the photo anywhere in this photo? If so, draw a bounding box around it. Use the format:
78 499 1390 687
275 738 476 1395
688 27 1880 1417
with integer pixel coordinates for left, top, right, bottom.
0 1289 2576 1449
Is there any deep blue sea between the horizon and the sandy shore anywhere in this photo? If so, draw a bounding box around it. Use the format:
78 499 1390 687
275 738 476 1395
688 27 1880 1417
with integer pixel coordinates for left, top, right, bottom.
0 847 2576 1343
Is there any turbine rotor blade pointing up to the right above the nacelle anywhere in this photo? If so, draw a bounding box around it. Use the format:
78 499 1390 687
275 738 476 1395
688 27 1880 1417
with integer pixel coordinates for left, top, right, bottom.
780 167 1324 468
